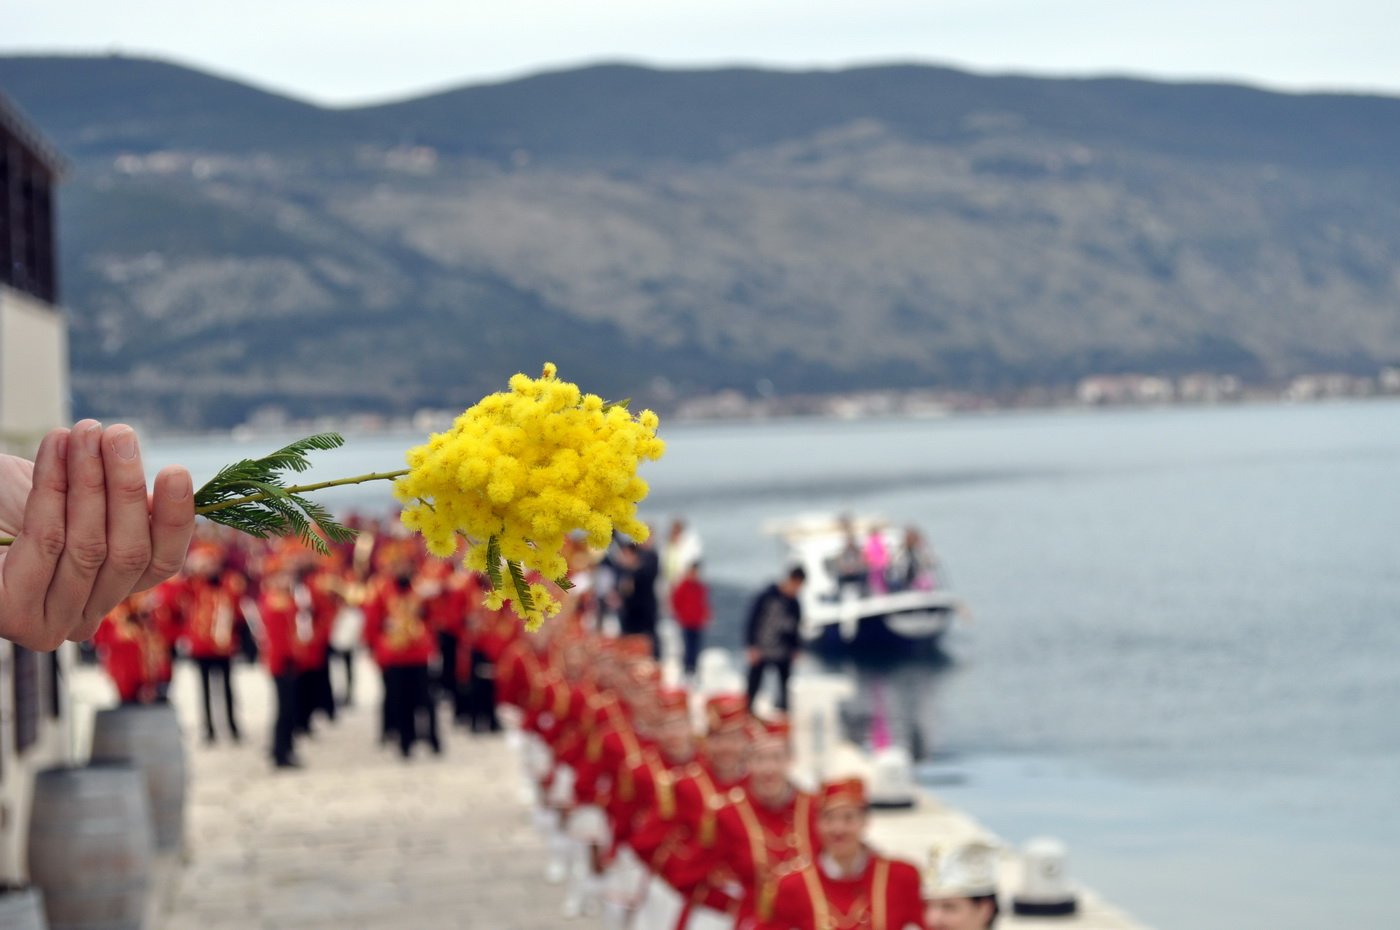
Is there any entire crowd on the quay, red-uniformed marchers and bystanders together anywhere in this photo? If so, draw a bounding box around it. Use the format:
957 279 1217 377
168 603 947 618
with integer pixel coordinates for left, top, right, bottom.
94 512 997 930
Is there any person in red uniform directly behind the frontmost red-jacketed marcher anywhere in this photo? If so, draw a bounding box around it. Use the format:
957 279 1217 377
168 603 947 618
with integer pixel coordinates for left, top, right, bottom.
694 720 818 930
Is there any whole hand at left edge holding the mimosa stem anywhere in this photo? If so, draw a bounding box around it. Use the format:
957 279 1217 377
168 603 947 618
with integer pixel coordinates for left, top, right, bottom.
0 420 195 651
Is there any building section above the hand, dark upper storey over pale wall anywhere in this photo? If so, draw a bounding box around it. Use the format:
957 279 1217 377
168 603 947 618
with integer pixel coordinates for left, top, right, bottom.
0 95 69 452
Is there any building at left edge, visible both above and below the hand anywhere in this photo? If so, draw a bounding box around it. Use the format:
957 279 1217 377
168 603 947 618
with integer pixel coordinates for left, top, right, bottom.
0 95 74 885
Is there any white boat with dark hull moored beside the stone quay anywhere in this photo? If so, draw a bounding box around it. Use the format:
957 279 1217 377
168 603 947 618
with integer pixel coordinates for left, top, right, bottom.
763 515 960 647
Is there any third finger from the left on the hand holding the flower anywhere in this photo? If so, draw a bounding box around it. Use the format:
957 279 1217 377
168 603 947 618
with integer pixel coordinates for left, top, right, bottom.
69 423 151 641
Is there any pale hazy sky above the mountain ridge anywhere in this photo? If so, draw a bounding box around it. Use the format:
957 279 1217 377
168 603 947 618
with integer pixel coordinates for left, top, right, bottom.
0 0 1400 104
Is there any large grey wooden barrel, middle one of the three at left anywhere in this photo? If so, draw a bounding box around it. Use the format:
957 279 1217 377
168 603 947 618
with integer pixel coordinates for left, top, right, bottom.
29 762 154 930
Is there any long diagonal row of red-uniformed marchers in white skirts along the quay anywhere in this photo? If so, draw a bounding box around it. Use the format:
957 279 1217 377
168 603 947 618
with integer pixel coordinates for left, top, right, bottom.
498 613 997 930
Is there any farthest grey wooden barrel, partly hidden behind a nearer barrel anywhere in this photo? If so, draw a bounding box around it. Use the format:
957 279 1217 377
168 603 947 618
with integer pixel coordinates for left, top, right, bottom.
92 705 185 853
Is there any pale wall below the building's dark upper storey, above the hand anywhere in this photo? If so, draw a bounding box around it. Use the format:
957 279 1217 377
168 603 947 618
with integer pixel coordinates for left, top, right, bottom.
0 286 69 455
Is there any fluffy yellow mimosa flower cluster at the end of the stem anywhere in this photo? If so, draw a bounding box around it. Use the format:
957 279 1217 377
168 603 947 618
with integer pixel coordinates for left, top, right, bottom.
395 364 665 629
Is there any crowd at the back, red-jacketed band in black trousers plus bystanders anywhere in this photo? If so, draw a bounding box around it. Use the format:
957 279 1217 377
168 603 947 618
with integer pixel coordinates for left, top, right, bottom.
92 518 710 768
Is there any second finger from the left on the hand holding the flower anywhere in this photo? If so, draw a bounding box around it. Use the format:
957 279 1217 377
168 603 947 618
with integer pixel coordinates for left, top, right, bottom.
43 420 106 639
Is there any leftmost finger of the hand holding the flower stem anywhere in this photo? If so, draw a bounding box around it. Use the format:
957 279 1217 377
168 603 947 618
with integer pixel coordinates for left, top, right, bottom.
0 430 70 651
